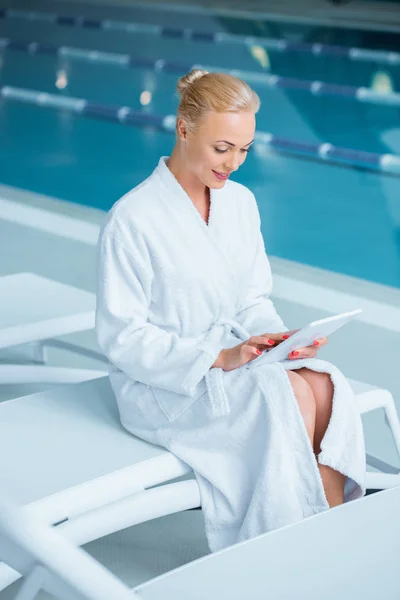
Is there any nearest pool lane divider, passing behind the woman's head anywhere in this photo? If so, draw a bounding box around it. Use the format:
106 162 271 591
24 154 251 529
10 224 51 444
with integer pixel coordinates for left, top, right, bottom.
0 86 400 176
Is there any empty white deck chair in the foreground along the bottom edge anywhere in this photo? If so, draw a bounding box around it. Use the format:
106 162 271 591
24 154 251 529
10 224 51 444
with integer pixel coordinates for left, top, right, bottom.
0 487 400 600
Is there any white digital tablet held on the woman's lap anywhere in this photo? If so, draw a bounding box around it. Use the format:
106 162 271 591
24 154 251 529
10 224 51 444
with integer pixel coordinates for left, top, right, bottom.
252 309 362 367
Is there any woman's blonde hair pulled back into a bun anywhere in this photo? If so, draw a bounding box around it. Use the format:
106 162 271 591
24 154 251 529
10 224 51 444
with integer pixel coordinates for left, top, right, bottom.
176 69 260 131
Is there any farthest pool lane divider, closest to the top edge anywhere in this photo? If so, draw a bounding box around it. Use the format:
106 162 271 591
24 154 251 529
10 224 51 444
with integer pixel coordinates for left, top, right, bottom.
0 8 400 65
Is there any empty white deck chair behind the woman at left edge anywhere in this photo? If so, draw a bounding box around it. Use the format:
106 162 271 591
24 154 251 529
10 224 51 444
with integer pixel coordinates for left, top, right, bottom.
0 273 107 384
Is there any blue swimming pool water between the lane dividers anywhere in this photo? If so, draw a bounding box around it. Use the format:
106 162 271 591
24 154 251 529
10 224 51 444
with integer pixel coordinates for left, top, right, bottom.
0 2 400 287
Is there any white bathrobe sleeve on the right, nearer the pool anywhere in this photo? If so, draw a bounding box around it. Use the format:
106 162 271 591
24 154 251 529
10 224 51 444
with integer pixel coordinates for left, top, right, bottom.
235 194 287 335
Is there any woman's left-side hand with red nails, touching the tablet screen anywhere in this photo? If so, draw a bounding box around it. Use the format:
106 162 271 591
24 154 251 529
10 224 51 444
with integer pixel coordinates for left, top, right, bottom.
212 332 287 371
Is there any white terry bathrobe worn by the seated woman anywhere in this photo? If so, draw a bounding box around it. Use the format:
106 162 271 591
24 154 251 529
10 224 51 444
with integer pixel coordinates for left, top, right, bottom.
96 157 366 551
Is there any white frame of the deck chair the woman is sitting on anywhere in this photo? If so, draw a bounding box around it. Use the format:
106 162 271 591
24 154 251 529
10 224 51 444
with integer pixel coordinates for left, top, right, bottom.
0 381 400 591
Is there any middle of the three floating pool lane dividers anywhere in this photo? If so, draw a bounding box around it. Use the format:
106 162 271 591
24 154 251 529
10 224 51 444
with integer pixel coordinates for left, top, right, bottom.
0 38 400 106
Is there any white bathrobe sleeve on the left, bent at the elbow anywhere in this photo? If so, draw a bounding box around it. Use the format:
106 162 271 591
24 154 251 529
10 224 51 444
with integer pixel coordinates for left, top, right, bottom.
96 220 223 396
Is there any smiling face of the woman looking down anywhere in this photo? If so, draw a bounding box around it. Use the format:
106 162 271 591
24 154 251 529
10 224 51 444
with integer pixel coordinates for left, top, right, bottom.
178 112 256 189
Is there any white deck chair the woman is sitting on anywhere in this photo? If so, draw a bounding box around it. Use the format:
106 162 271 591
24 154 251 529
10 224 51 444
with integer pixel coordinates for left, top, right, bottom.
0 378 400 590
